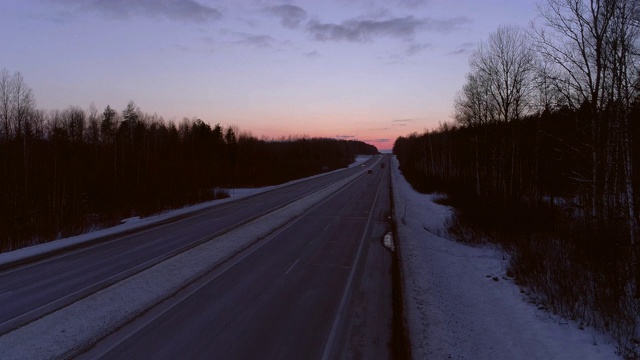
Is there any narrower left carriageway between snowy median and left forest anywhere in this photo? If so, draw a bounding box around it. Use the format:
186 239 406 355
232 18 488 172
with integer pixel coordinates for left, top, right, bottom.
0 158 377 335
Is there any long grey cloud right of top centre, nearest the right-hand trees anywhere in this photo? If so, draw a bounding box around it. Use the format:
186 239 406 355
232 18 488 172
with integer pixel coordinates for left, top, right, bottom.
307 16 469 42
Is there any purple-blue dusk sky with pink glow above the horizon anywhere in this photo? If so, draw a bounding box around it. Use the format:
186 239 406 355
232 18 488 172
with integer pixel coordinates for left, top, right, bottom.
0 0 536 150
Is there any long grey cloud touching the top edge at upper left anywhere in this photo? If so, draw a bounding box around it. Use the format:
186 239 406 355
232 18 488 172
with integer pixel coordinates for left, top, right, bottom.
50 0 222 23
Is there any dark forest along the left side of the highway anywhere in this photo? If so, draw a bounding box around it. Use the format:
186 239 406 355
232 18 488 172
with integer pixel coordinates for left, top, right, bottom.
0 69 378 251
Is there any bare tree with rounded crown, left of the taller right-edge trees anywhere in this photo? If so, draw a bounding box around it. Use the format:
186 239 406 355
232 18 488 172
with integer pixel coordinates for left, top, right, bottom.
454 26 536 200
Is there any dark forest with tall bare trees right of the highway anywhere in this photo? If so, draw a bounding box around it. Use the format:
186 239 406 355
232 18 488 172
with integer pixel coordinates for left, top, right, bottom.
393 0 640 358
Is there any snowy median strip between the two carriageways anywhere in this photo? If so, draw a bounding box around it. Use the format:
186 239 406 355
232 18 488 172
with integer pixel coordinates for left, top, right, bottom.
0 165 370 359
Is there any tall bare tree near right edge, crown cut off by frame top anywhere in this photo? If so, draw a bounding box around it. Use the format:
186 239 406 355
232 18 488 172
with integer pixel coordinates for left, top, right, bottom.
534 0 616 220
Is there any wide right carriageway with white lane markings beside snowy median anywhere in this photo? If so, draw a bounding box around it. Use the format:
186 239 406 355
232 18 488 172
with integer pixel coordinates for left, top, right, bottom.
80 156 393 359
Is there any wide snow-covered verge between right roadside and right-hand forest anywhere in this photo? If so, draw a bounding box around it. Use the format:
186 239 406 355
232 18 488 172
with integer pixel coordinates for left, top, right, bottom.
392 157 619 360
